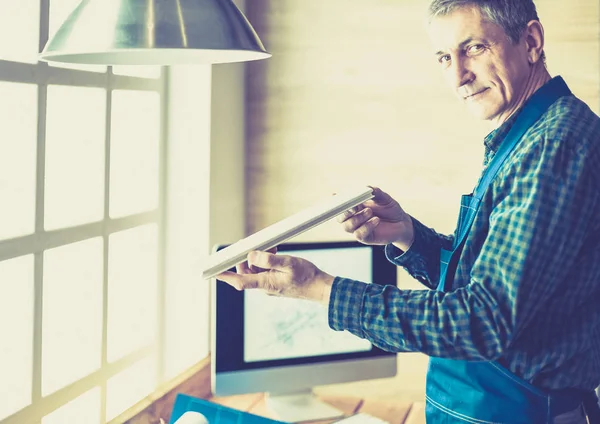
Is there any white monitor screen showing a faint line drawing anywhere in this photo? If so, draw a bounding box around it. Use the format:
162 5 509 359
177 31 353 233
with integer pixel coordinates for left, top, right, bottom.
244 246 372 362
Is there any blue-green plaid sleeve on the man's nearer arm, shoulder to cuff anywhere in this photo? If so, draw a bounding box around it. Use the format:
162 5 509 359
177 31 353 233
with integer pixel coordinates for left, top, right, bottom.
329 133 596 360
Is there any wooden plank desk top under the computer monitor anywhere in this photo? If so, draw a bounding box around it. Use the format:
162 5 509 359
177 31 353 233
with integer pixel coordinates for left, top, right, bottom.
209 393 425 424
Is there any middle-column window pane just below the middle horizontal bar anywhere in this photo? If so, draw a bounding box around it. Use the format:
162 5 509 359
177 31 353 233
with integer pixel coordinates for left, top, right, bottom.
42 238 103 396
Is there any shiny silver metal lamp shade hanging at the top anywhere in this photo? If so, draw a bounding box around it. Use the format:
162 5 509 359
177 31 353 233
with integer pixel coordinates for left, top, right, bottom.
40 0 271 65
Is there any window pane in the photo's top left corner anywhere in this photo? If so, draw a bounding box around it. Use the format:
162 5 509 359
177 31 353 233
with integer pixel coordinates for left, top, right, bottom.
0 0 40 63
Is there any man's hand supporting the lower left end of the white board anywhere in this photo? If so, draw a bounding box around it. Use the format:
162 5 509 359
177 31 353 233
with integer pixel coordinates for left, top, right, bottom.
217 251 334 305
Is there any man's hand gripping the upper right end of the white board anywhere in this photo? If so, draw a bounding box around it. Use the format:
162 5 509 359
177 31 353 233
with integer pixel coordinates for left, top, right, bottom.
337 187 414 251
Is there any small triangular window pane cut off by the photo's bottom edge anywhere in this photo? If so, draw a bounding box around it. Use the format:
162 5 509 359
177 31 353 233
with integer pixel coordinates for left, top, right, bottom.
42 388 100 424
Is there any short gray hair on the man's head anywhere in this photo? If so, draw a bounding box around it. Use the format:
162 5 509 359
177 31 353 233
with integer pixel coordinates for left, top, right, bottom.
429 0 539 44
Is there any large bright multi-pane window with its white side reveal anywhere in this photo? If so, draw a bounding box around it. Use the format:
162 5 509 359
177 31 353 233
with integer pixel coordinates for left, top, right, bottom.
0 0 211 424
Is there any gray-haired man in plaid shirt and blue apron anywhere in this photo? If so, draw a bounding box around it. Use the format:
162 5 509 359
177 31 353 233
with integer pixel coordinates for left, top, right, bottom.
219 0 600 423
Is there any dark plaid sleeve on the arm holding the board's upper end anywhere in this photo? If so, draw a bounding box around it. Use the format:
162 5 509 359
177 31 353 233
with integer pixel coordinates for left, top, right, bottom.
385 218 454 289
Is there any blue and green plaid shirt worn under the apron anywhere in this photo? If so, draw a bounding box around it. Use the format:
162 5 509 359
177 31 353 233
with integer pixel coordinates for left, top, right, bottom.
329 77 600 389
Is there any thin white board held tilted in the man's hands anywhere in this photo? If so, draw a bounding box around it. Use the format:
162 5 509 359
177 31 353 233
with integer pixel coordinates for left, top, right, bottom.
202 187 373 279
